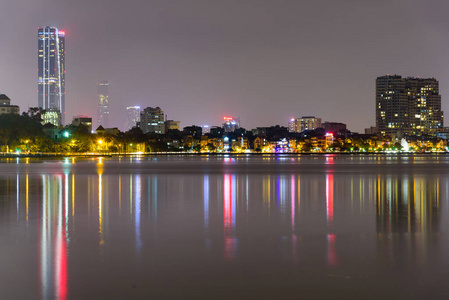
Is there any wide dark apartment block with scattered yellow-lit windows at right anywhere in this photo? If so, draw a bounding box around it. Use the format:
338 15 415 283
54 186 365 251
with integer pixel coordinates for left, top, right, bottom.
376 75 443 135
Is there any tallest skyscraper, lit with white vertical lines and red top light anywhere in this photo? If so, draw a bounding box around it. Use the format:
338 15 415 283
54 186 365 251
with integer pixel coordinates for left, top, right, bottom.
37 26 65 125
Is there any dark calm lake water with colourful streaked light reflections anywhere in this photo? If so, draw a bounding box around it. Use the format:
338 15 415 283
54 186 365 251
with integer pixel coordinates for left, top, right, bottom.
0 155 449 299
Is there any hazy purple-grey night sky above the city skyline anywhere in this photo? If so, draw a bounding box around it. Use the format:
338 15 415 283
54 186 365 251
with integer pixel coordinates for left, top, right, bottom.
0 0 449 131
